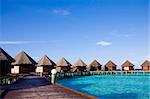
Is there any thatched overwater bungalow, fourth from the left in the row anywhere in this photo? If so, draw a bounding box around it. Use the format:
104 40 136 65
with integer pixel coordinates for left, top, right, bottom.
56 57 71 72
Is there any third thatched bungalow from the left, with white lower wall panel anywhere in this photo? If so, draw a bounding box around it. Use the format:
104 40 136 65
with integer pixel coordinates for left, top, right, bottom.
36 55 56 74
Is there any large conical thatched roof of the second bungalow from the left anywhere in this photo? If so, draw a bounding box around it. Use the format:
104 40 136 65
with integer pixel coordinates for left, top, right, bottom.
12 51 36 65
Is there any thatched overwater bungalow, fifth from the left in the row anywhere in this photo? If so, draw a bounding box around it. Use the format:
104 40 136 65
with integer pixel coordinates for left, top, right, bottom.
71 59 87 72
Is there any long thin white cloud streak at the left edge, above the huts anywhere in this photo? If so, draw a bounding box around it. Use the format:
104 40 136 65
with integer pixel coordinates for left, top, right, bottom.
0 41 32 45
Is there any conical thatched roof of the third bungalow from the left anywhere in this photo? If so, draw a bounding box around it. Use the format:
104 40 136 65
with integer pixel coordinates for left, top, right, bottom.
37 55 56 66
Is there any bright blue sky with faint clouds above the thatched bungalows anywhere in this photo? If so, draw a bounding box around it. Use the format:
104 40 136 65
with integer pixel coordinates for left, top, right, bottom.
0 0 150 68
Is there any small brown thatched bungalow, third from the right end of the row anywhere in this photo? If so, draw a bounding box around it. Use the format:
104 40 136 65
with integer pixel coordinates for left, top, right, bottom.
104 60 117 71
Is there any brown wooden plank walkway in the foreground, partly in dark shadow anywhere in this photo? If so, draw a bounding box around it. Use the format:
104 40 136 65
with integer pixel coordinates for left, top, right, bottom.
4 76 95 99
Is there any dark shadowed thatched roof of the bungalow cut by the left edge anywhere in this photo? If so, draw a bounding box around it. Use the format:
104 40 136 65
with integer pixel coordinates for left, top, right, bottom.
0 48 15 62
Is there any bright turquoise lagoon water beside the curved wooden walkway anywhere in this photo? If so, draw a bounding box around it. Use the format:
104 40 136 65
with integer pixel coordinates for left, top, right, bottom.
58 75 150 99
